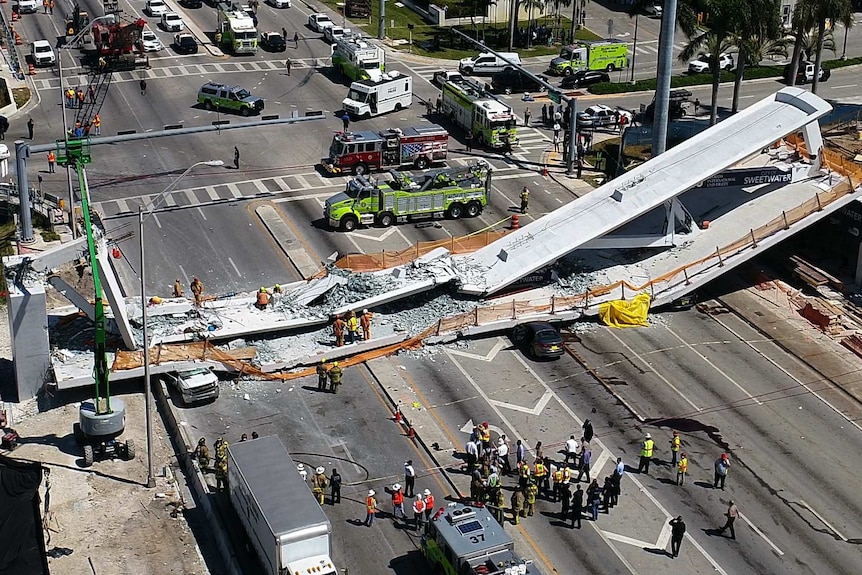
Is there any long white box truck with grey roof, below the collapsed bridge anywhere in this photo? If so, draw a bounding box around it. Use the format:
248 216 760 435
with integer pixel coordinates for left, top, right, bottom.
228 435 338 575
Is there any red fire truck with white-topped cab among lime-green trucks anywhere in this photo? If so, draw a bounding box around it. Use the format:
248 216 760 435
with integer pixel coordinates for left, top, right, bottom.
322 126 449 176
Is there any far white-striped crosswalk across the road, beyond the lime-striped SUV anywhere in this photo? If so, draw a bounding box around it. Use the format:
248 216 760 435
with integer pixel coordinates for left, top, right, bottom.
33 57 329 92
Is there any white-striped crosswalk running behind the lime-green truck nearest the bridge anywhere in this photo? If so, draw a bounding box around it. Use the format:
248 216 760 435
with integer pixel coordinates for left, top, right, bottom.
98 155 538 220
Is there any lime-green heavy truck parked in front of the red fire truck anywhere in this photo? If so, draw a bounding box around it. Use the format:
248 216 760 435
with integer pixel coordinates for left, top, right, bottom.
323 160 492 232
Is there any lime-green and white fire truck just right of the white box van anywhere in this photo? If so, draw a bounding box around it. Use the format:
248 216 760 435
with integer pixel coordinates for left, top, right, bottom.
443 78 518 148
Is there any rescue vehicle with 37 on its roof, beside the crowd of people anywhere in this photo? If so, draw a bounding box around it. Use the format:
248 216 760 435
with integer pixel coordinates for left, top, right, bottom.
420 503 541 575
